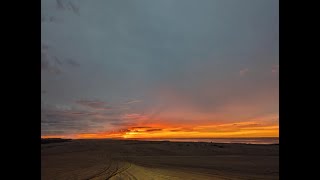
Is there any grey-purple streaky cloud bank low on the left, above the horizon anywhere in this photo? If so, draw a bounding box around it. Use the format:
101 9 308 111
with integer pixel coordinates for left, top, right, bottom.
41 100 134 135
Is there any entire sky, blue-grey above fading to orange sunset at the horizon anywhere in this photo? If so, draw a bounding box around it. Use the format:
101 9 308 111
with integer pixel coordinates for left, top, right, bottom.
41 0 279 138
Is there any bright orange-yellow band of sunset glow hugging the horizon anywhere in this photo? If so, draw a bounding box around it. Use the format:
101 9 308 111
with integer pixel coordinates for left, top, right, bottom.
42 112 279 139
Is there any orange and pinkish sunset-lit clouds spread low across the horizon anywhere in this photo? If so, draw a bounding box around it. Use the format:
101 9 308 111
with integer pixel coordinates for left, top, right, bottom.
43 97 279 139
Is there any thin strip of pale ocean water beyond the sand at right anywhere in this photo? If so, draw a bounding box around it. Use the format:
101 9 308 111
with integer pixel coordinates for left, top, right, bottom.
139 138 279 144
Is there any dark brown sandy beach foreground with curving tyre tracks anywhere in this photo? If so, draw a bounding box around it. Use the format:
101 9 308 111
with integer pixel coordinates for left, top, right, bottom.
41 140 279 180
